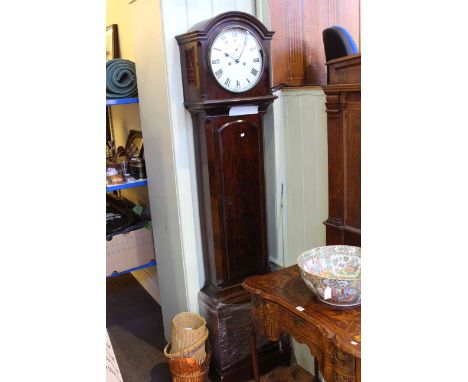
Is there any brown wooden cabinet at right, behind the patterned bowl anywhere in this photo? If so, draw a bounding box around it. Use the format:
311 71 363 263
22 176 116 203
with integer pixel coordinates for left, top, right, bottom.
324 54 361 246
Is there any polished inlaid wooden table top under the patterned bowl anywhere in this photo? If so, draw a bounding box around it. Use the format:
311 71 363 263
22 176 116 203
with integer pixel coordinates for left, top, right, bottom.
243 265 361 358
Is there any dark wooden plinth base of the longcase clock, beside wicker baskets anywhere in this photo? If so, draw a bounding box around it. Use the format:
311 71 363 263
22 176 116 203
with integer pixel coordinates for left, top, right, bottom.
198 285 291 382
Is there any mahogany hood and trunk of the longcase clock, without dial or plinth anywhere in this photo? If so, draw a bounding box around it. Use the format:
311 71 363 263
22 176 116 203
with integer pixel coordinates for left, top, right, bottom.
176 12 276 292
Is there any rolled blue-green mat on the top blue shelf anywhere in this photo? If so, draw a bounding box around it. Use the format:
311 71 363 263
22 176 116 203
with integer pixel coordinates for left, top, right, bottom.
106 58 138 98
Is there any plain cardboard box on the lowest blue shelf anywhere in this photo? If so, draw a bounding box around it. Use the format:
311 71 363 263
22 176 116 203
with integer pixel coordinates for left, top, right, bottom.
106 228 155 276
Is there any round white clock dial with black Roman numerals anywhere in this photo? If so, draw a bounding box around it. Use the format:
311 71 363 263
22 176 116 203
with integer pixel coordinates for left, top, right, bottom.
210 27 263 93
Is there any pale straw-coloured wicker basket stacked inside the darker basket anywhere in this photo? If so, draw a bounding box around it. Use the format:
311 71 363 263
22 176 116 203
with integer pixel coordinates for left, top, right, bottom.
171 312 206 360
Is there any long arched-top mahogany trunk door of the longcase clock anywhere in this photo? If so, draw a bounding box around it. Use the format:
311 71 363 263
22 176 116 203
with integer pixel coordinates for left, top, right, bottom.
214 116 267 286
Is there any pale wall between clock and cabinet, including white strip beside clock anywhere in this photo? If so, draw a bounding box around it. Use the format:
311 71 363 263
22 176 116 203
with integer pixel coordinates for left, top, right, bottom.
265 86 328 266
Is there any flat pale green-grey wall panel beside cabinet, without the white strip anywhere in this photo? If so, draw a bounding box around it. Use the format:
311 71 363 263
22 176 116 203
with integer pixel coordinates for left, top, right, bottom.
281 87 328 266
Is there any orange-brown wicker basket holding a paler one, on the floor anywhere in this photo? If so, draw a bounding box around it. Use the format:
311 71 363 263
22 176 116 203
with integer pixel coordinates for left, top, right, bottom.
164 340 211 382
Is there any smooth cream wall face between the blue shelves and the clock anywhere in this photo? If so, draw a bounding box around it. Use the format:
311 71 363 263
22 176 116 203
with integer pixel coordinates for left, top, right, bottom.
128 0 195 336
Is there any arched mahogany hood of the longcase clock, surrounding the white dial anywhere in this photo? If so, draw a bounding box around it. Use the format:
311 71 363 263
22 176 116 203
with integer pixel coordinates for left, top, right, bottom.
176 12 274 109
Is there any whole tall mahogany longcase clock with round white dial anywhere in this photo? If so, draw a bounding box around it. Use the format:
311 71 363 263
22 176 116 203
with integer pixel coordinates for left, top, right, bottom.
176 12 288 381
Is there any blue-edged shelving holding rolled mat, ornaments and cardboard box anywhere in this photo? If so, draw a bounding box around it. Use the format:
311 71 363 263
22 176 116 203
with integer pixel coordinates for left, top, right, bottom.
106 57 156 277
